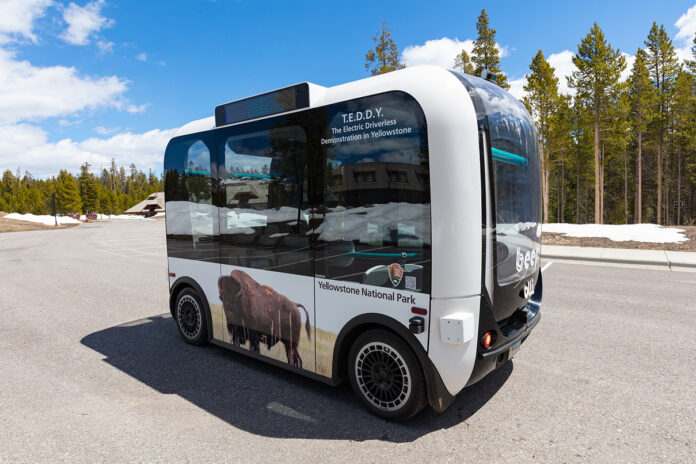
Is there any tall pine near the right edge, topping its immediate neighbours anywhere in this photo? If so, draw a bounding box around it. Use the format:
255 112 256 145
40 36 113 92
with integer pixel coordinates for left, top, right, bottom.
645 23 679 224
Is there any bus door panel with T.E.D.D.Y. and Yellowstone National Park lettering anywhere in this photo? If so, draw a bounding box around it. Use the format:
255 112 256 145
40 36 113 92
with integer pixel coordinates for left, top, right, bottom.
312 92 431 376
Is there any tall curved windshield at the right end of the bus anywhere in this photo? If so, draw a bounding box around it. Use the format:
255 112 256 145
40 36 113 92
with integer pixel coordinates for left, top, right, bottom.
454 73 541 285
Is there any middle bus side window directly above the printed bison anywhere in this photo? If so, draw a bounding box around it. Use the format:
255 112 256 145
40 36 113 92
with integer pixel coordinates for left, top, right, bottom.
217 122 311 275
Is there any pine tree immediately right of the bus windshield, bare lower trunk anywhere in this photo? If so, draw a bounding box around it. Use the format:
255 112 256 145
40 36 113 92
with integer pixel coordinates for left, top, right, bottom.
522 50 560 222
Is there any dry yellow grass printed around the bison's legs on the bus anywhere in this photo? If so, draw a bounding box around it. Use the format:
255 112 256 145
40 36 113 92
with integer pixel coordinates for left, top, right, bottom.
210 304 337 377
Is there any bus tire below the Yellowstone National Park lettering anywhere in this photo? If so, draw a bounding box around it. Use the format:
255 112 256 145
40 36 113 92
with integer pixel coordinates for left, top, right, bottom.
348 329 426 421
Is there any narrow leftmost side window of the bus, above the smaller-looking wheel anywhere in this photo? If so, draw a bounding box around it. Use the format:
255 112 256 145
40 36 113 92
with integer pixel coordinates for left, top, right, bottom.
165 134 219 261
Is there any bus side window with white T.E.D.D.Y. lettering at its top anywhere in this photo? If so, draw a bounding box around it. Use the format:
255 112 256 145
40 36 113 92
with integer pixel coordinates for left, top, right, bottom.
315 92 431 292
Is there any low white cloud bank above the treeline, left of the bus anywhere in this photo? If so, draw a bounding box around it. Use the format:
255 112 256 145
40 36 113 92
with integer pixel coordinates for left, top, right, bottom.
0 124 178 177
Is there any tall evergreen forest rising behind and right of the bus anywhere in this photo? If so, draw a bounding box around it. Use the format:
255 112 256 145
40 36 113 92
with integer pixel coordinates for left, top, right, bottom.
365 10 696 225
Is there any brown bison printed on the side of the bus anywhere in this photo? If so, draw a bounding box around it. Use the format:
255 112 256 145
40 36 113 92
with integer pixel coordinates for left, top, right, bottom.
218 270 312 367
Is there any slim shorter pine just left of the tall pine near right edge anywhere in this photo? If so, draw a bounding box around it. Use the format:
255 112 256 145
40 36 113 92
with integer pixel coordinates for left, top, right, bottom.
628 48 655 224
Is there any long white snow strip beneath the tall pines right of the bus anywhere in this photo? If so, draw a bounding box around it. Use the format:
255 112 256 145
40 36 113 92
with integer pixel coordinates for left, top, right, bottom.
542 224 689 243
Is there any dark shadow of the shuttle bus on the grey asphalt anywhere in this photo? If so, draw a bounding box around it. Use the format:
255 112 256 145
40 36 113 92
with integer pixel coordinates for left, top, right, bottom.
81 314 513 442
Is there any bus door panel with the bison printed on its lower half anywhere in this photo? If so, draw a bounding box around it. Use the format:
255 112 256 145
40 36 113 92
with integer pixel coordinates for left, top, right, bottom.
215 117 315 372
